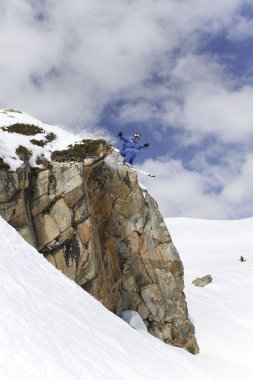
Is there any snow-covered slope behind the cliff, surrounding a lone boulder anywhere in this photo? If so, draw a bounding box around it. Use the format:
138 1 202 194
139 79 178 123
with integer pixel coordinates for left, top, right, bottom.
166 218 253 380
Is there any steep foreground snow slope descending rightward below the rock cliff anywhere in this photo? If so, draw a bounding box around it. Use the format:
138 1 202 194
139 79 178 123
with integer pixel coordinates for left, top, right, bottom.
0 219 197 380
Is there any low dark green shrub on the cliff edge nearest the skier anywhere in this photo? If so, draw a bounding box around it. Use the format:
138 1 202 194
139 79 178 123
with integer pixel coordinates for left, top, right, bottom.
51 139 110 162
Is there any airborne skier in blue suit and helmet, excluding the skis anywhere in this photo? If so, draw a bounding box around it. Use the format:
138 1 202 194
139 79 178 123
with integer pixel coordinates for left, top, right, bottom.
118 132 149 166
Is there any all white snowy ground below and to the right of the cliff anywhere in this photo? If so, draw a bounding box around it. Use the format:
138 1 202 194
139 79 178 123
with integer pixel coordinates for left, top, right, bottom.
0 218 253 380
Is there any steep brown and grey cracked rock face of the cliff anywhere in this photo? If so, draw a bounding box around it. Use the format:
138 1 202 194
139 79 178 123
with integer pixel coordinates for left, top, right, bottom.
0 151 198 353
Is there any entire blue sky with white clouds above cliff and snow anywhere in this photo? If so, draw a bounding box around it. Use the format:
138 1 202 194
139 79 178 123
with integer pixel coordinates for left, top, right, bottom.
0 0 253 219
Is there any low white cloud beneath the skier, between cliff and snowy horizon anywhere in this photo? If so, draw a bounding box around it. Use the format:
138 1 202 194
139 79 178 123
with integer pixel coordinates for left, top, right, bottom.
139 159 228 219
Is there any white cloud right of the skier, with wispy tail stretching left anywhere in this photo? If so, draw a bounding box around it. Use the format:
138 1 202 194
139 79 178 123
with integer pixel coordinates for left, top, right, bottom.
118 54 253 144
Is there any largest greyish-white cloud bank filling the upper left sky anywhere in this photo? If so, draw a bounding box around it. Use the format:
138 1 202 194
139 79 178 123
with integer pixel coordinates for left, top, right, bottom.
0 0 252 129
